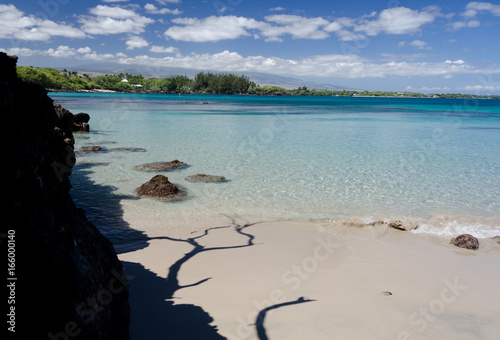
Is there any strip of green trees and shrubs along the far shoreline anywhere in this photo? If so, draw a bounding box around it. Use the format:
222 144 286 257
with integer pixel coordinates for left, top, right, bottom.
17 66 500 99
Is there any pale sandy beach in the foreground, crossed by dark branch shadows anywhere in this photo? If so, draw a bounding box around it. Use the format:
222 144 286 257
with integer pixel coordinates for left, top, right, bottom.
119 214 500 339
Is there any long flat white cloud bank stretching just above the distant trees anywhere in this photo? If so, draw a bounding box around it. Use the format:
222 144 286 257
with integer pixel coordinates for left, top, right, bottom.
111 51 500 79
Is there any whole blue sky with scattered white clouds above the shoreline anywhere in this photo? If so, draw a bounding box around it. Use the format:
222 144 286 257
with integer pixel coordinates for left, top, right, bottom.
0 0 500 94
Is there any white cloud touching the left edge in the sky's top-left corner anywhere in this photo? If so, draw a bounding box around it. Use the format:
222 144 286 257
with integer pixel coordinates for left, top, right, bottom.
0 4 86 41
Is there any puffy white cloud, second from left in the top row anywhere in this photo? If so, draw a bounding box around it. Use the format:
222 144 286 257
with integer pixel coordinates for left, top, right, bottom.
79 5 154 35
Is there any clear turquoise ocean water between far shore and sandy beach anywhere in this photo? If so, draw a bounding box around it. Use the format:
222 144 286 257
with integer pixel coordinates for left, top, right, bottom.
50 93 500 237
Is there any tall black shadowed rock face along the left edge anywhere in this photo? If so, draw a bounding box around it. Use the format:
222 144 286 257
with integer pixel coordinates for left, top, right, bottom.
0 53 129 339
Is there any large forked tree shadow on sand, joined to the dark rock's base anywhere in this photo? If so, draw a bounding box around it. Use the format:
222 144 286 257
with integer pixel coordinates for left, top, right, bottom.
122 219 257 340
